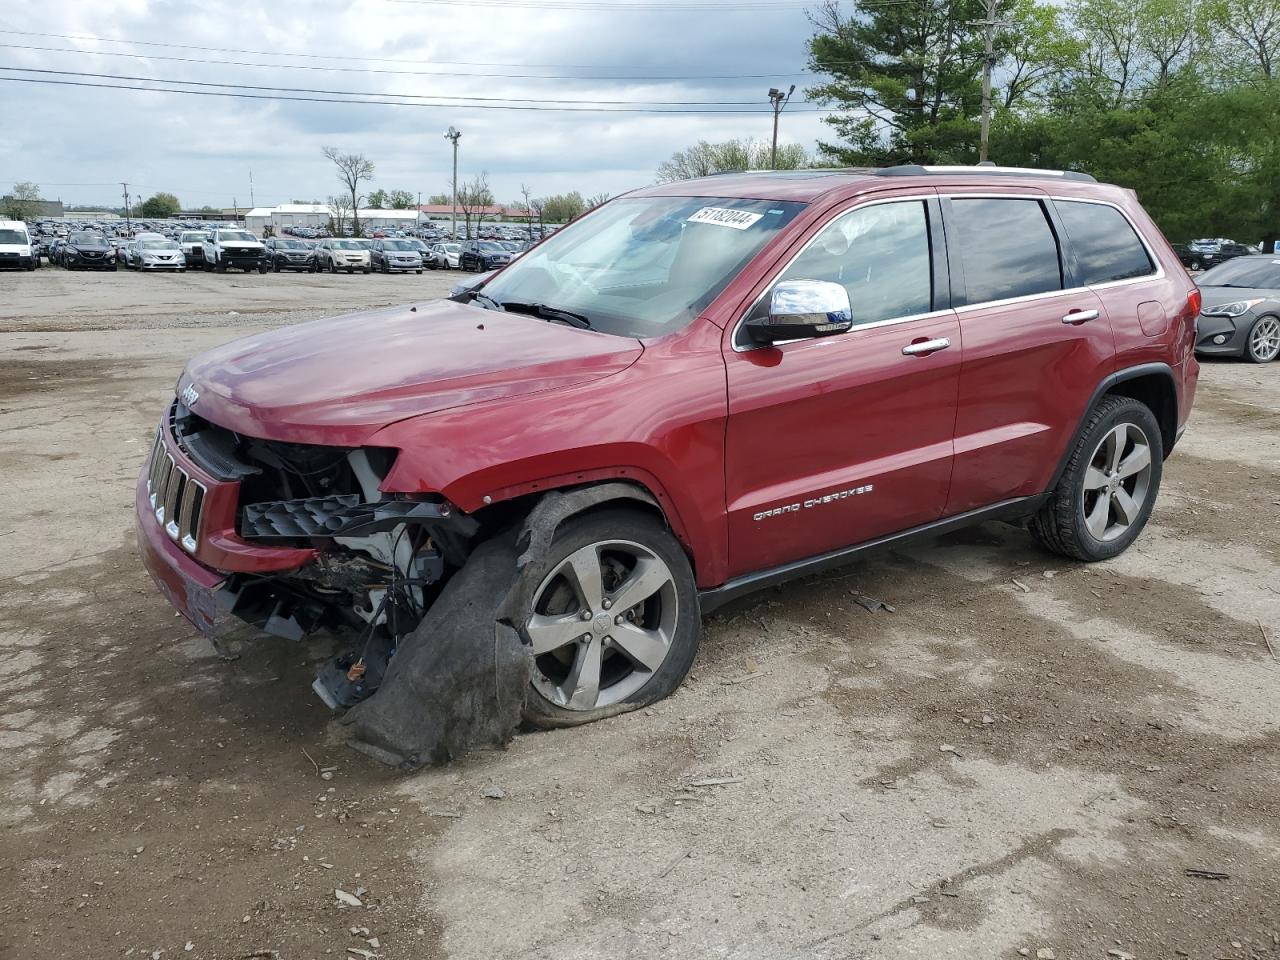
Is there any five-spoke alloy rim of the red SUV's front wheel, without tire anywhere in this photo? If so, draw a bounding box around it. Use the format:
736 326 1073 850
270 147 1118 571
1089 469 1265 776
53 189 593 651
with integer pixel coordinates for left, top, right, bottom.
526 540 678 710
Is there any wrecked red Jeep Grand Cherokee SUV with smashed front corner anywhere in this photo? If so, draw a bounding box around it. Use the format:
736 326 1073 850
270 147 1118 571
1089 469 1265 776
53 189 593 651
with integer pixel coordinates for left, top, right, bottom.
137 166 1199 726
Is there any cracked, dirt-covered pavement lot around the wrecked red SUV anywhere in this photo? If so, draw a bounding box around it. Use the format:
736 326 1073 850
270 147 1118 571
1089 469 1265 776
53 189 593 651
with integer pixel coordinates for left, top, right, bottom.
0 270 1280 960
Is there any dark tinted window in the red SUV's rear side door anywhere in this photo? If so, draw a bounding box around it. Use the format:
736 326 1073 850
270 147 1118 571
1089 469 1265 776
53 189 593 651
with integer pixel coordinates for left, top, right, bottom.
951 197 1062 303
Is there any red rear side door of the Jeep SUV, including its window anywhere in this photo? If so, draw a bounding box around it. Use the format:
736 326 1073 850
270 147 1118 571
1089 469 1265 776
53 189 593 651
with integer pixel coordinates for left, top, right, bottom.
942 188 1115 516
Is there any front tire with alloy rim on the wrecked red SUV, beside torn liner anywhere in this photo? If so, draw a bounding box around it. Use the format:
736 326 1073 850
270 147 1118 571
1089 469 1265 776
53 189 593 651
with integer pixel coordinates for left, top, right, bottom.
518 508 701 730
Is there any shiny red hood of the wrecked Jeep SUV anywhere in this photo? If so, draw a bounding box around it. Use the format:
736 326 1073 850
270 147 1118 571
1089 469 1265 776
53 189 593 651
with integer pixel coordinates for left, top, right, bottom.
178 301 644 447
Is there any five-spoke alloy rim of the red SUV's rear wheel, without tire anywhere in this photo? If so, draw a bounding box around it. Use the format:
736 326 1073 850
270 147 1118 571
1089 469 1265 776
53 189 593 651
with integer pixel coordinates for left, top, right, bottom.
1080 422 1151 543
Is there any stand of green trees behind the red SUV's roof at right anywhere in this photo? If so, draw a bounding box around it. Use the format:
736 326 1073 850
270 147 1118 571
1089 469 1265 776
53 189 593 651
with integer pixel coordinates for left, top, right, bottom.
808 0 1280 242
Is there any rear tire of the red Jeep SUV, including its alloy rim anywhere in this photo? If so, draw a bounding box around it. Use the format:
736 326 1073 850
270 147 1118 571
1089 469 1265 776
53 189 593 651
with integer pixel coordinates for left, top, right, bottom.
1030 397 1165 563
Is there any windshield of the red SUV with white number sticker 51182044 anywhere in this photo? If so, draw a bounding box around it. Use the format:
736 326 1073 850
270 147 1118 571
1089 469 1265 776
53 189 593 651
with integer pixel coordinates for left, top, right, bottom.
484 197 804 337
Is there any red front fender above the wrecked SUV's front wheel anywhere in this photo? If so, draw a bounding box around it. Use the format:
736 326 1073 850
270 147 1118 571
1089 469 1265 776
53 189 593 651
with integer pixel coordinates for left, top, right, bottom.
366 321 727 586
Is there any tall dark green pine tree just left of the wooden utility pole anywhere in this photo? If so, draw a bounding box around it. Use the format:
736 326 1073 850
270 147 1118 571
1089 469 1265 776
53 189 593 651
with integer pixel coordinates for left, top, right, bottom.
806 0 984 166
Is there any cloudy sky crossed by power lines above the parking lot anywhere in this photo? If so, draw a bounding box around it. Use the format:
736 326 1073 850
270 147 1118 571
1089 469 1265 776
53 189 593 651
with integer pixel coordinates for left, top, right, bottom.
0 0 823 207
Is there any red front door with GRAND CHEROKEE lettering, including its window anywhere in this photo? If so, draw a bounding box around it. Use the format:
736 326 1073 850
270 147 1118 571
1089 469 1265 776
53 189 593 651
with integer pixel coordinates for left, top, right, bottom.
724 195 961 576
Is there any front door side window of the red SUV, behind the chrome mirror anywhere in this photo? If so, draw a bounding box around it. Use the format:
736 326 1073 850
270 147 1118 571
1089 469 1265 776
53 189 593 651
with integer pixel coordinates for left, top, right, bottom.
751 200 933 325
